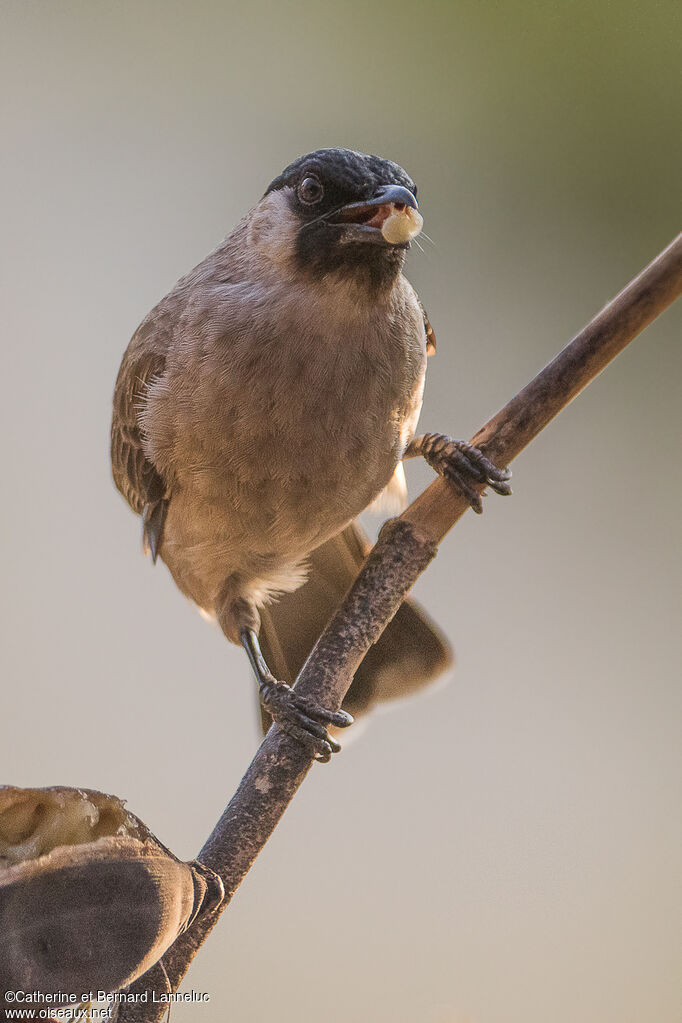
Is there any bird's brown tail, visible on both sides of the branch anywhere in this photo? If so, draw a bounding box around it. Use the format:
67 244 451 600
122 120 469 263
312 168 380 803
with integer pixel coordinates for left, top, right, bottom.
260 522 452 730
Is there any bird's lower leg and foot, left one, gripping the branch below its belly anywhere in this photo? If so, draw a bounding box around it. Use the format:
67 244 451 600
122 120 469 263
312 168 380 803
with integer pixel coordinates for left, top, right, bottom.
239 628 353 762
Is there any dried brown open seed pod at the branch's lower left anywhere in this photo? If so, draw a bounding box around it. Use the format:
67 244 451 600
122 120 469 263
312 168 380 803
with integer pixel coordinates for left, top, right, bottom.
0 786 224 1007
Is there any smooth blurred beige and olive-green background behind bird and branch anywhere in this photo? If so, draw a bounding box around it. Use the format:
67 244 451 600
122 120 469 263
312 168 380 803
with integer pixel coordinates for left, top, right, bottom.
0 0 682 1023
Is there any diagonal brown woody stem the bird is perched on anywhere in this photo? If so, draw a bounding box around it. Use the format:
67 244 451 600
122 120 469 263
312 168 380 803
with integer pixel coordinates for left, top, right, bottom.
114 234 682 1023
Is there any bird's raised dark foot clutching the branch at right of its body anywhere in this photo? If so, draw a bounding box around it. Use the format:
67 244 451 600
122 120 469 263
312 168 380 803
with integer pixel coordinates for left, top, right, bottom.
403 434 511 515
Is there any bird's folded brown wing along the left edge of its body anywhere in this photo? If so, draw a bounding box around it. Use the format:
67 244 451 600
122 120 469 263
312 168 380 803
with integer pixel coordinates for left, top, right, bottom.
111 313 170 561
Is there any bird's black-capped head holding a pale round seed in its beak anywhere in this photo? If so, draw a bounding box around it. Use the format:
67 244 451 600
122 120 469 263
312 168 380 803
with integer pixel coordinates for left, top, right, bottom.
259 149 422 288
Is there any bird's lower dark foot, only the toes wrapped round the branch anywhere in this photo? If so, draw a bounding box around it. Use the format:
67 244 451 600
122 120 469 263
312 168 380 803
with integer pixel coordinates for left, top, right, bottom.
260 678 353 763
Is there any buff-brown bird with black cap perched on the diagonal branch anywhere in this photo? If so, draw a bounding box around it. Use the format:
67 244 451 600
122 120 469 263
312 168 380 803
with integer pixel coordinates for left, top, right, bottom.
110 147 510 762
